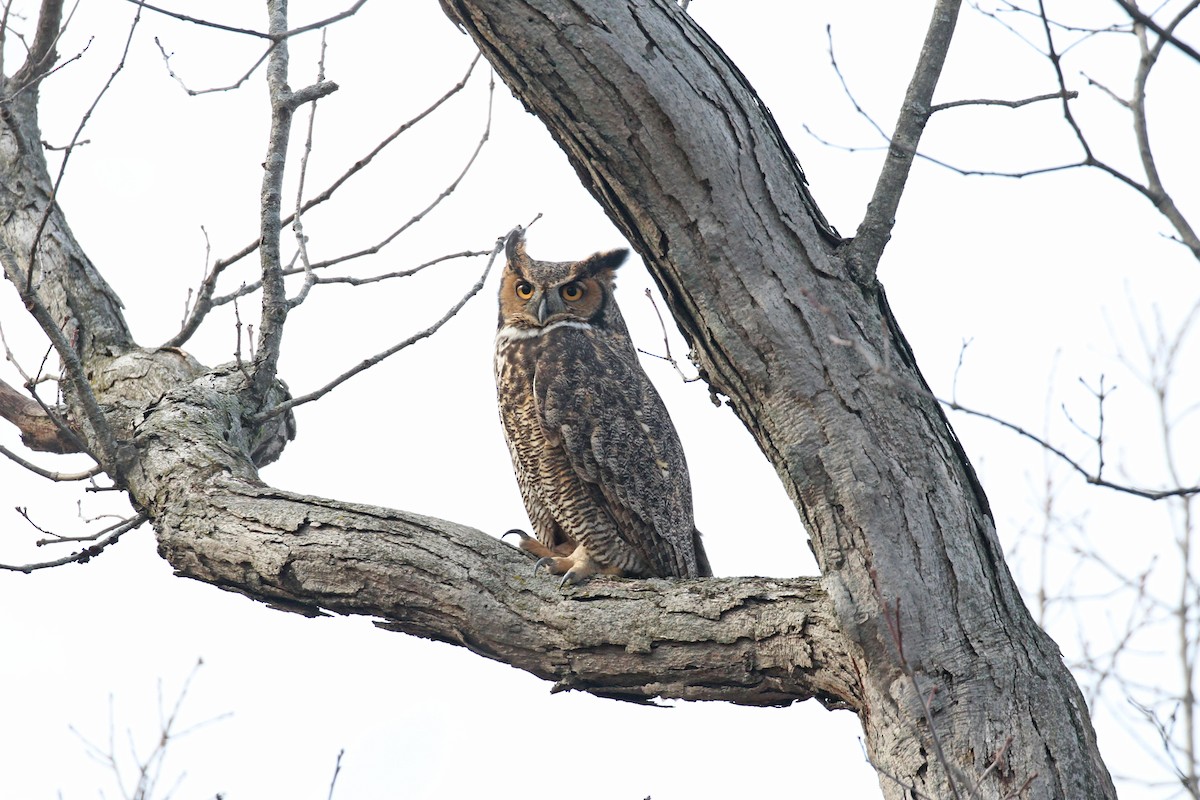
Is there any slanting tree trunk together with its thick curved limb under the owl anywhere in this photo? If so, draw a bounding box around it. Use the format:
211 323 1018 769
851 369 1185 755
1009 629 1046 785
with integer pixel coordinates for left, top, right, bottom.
0 0 1114 799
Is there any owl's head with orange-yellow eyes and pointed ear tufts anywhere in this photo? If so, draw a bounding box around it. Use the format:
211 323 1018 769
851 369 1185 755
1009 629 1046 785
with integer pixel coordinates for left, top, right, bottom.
500 228 629 329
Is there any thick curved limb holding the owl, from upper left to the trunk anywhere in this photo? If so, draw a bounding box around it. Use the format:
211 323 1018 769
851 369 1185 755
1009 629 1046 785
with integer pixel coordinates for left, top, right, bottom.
0 0 859 708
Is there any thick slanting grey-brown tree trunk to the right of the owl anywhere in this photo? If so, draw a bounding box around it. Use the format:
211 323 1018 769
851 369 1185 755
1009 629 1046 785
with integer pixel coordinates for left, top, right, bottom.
443 0 1115 799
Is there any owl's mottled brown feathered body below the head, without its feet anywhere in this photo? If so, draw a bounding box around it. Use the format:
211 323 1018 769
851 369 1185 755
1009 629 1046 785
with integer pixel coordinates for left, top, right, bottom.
496 320 697 576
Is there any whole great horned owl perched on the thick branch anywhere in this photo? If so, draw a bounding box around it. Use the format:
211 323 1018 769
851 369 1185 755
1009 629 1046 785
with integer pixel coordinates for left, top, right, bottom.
496 228 712 584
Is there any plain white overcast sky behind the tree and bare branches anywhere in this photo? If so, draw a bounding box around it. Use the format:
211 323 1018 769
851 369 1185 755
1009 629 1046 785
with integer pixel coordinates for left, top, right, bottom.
0 0 1200 800
